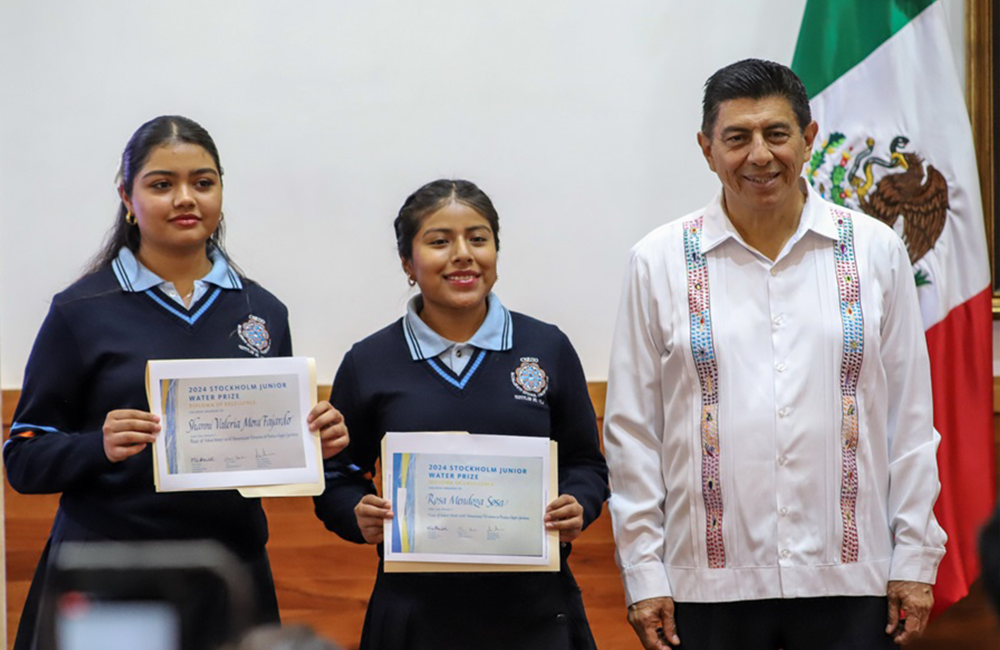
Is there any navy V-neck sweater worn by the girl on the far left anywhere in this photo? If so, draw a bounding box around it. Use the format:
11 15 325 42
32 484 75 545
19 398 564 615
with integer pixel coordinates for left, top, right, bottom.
3 267 292 557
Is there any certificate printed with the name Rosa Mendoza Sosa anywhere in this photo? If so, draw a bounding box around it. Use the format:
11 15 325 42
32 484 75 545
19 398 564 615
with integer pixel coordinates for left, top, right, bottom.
382 433 559 572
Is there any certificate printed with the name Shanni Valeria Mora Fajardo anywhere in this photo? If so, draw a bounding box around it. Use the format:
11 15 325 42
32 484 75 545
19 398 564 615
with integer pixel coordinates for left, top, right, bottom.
146 357 323 496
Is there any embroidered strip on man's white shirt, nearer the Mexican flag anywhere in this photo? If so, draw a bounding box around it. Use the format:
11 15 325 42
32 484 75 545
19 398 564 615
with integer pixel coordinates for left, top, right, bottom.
833 210 865 562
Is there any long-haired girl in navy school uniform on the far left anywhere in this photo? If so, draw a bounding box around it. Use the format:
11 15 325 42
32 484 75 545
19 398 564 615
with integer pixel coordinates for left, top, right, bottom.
3 116 347 650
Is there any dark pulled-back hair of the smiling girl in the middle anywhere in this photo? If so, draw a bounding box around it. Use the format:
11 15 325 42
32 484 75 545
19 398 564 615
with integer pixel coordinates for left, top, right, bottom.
392 178 500 262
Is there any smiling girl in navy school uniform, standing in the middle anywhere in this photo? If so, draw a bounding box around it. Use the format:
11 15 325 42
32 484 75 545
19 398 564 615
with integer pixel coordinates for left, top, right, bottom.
316 180 607 650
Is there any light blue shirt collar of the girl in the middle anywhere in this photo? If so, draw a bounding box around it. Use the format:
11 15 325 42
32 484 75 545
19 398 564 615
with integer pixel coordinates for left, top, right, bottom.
403 293 514 361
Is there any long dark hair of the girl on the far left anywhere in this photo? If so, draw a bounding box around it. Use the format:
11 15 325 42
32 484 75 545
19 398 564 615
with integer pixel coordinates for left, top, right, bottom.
86 115 243 276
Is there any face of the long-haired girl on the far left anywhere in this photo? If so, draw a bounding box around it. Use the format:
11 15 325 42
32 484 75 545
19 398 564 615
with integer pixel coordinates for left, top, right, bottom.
119 142 222 255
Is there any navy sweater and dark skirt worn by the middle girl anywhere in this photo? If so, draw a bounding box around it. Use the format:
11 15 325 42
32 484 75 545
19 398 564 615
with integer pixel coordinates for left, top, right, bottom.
315 313 608 650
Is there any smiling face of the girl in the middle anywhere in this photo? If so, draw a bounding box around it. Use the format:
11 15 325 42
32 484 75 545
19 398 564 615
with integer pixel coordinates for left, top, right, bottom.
403 202 497 315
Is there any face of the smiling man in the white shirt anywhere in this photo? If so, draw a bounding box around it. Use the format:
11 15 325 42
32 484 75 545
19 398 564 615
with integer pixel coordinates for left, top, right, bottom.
698 95 817 216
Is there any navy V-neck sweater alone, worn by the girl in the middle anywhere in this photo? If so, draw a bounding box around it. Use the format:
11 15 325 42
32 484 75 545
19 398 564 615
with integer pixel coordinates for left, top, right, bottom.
316 312 607 542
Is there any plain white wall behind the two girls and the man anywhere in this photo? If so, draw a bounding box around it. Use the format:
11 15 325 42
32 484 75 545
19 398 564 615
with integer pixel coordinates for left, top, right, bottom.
0 0 962 388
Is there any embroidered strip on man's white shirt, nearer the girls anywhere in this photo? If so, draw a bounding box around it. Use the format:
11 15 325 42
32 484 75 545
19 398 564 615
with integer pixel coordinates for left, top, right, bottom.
684 216 726 569
